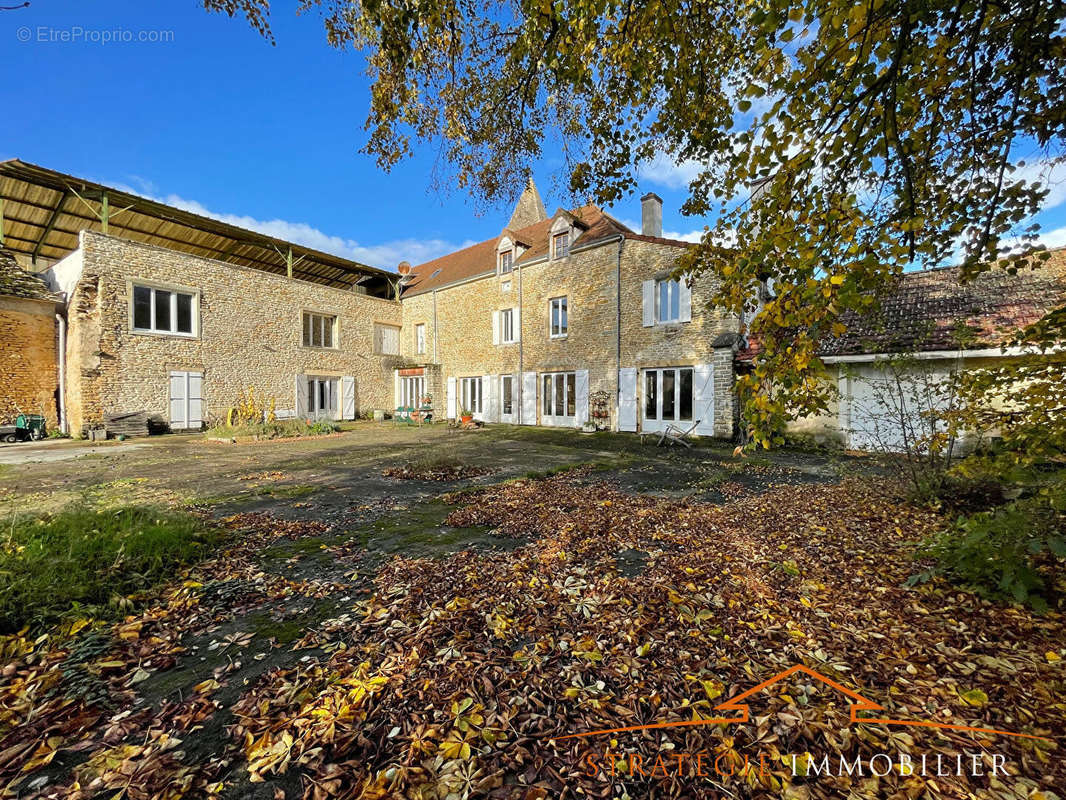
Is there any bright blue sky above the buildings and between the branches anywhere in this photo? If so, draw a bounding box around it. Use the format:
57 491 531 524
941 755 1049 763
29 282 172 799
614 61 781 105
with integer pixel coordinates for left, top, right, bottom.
0 0 1066 269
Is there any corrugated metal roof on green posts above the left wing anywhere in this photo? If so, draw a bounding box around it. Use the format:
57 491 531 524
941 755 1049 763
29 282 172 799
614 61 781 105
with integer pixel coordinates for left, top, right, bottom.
0 159 394 295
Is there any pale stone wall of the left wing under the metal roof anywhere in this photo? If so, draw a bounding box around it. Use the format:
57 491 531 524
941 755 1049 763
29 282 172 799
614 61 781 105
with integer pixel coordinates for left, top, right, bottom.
67 231 402 433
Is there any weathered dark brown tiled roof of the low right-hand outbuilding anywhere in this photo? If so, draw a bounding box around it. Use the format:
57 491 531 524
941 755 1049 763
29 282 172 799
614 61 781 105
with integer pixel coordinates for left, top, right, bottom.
737 249 1066 362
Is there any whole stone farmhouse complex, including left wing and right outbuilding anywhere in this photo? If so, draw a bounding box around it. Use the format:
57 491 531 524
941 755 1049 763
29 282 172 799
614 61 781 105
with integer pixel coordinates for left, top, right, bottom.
0 161 1066 448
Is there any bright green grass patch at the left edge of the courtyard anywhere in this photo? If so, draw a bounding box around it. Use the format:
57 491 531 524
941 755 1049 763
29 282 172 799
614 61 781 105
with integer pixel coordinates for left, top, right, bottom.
0 507 222 633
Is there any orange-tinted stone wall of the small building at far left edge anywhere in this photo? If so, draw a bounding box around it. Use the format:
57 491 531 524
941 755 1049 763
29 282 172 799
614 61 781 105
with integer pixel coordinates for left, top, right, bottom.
0 295 59 428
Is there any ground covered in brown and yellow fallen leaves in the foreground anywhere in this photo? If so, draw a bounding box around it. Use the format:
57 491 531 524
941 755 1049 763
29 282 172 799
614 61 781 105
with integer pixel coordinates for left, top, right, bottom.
0 470 1066 800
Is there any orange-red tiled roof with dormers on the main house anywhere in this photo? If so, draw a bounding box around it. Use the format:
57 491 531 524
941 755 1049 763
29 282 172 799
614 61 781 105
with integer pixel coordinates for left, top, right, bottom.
404 204 693 297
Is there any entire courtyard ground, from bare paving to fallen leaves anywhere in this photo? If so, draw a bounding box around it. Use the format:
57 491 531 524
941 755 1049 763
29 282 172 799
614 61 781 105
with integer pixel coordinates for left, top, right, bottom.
0 423 1066 800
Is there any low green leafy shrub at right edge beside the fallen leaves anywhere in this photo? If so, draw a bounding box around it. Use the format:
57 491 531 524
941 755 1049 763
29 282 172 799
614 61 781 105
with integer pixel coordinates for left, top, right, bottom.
908 497 1066 611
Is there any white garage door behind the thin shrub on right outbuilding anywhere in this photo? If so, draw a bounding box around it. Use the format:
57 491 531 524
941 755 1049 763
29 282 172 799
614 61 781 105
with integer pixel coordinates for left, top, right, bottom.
841 364 950 452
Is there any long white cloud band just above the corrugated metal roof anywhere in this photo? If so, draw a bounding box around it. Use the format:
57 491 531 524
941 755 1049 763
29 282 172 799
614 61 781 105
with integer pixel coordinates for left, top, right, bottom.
116 186 474 271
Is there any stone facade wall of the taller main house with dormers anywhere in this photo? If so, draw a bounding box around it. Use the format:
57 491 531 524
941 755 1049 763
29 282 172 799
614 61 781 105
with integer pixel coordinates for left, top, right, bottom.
402 234 739 437
